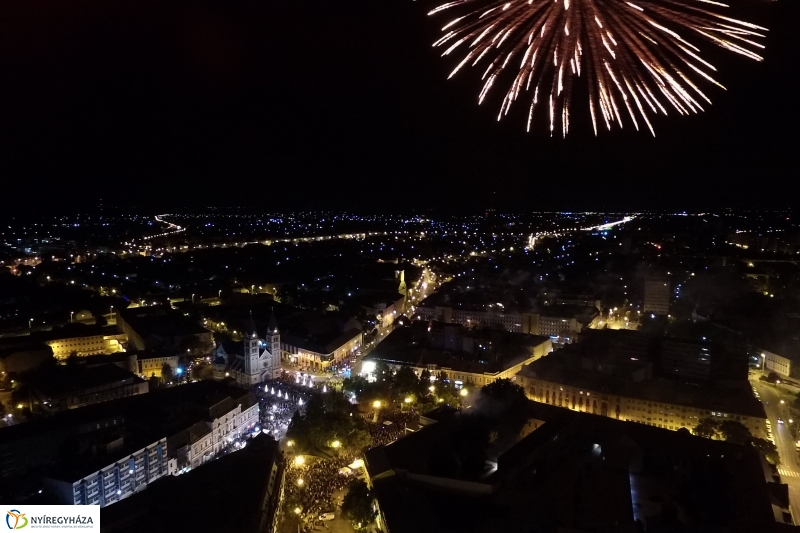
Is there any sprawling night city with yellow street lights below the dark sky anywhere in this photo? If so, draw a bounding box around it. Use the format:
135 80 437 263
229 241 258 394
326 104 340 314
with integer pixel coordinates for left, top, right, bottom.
0 206 800 533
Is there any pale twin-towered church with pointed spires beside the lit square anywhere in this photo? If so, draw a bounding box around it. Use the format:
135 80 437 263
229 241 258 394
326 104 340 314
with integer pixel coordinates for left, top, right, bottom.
213 313 281 387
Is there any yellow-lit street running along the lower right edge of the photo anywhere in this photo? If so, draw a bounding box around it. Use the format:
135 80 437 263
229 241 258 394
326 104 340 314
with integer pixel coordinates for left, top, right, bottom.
750 380 800 520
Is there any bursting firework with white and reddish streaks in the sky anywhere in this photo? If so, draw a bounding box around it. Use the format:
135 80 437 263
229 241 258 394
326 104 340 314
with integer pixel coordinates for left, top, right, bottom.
429 0 766 136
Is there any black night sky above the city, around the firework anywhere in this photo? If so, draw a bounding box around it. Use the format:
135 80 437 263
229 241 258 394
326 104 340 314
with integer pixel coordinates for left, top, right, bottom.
0 0 800 211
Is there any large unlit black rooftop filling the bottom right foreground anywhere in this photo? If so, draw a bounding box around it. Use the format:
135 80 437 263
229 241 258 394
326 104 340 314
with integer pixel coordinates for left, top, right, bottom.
366 396 776 533
